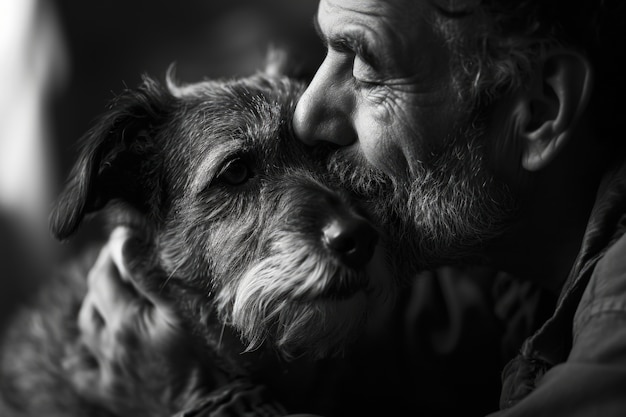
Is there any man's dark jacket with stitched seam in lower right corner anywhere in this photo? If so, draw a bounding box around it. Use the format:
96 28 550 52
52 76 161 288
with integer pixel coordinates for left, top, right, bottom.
492 158 626 417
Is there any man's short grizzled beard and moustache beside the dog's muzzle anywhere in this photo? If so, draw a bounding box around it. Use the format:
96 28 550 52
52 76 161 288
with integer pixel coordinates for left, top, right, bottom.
328 117 518 276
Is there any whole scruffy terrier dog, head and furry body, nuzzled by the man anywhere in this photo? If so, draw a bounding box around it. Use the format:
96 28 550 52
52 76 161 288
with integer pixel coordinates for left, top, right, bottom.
0 65 391 416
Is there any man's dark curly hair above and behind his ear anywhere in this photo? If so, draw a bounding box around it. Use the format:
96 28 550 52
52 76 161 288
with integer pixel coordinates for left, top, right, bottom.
432 0 626 138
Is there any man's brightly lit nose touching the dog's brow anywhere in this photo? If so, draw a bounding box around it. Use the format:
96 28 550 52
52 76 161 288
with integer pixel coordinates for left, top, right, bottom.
293 57 357 146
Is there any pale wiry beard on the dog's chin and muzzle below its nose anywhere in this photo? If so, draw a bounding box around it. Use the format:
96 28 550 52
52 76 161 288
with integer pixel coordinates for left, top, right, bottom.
217 229 394 359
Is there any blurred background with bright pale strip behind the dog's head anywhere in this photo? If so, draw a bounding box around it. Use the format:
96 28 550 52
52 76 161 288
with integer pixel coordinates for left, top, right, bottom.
0 0 323 325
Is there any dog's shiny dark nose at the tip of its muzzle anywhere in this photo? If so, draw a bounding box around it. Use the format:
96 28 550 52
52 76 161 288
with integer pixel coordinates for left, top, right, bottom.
323 217 378 268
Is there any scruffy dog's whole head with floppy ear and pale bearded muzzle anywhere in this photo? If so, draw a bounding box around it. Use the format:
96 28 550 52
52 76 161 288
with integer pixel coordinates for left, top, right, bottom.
51 70 391 356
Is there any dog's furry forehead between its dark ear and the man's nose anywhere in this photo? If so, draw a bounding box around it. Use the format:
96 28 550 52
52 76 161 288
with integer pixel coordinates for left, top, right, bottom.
165 81 295 192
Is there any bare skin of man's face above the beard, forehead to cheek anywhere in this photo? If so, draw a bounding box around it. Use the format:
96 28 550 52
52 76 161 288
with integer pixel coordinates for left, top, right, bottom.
295 0 460 182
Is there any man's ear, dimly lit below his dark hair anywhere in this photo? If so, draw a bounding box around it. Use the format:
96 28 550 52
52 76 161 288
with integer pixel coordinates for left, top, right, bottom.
510 50 592 171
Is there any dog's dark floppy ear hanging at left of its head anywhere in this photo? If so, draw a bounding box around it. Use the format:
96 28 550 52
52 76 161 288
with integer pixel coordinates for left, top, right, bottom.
50 77 173 239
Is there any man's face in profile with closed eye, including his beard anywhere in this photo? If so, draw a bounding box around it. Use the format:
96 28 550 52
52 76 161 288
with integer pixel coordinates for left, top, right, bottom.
294 0 513 266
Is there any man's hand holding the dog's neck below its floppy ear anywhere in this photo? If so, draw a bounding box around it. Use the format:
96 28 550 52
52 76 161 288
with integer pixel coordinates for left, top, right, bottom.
66 228 202 416
